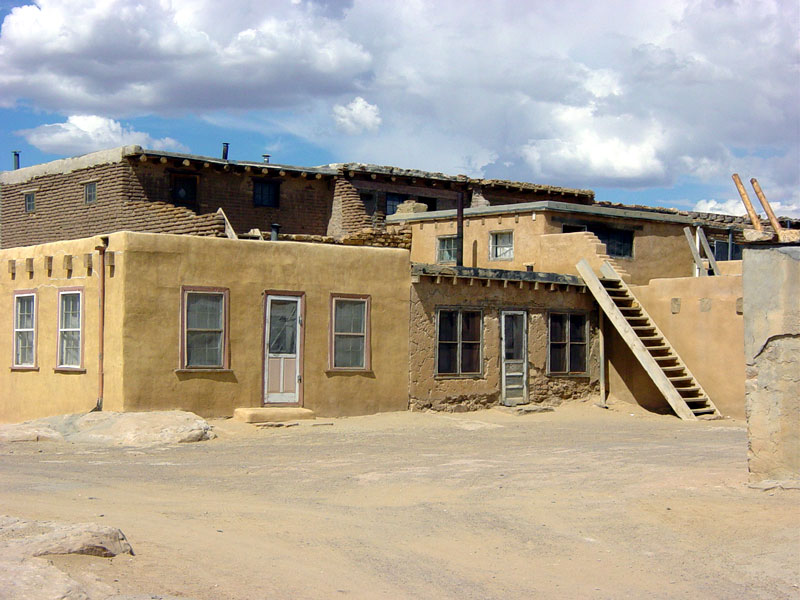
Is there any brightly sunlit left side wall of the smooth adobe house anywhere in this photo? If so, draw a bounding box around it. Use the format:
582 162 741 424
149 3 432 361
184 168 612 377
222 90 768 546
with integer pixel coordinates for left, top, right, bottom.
0 238 123 422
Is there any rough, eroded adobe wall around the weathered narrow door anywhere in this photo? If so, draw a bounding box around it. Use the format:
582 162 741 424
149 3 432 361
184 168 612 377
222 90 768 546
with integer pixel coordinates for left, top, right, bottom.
408 277 599 411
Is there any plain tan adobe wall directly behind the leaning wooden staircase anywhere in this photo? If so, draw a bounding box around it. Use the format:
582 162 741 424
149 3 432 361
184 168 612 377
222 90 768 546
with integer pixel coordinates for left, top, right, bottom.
604 276 745 419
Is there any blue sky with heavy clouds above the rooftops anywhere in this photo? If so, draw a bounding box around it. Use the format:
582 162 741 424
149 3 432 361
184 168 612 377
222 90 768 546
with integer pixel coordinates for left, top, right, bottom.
0 0 800 216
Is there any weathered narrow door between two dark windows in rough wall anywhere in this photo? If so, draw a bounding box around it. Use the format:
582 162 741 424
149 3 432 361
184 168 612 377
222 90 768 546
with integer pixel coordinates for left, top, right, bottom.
500 310 528 406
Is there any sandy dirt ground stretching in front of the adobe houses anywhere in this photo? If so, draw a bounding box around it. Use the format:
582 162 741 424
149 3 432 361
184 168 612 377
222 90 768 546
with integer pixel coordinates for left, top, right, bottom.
0 402 800 600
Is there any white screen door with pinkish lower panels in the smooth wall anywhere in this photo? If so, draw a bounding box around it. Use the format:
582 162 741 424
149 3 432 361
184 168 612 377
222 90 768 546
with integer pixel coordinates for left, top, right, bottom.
264 296 302 404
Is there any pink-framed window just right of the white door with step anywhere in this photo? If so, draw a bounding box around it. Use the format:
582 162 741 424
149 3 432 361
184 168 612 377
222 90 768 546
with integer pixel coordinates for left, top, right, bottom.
331 296 370 371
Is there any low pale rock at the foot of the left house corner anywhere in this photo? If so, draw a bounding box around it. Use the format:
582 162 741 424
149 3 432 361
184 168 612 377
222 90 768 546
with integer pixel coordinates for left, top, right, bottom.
0 410 216 446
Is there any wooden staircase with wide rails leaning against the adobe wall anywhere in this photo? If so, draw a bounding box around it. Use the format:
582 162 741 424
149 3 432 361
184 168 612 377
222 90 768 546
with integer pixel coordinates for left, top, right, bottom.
576 259 721 420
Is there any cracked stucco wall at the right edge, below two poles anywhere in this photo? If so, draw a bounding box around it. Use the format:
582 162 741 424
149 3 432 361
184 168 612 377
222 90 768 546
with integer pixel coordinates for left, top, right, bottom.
742 246 800 481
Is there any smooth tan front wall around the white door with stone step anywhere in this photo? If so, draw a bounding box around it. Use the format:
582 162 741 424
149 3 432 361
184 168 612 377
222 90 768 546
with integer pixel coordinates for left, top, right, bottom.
112 233 410 416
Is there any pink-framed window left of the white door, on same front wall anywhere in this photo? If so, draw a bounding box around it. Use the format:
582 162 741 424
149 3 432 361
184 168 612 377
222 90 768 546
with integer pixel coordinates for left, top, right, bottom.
181 287 228 369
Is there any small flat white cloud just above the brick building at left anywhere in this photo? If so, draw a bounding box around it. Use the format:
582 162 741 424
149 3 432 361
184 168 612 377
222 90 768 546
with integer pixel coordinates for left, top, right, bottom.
17 115 187 155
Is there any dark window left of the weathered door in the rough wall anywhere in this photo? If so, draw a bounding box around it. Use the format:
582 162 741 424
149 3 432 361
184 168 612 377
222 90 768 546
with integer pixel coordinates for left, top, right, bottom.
436 309 483 375
